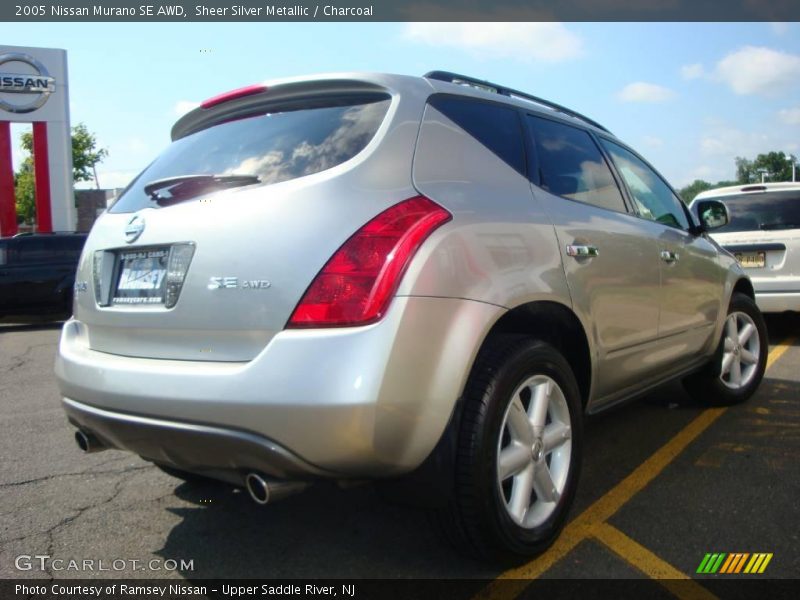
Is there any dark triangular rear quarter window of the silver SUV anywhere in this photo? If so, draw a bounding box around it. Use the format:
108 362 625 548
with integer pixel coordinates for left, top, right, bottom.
429 96 525 175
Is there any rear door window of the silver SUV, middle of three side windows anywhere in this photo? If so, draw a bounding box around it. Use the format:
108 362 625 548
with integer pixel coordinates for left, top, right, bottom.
528 115 626 212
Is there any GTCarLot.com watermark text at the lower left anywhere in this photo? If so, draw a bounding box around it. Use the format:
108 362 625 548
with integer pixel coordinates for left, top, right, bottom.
14 554 194 573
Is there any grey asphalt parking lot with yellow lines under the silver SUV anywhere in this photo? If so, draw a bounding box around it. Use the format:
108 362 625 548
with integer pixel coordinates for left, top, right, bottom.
0 316 800 598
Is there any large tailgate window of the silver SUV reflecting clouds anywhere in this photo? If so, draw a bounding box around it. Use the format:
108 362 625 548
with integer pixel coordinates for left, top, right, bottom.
109 95 391 213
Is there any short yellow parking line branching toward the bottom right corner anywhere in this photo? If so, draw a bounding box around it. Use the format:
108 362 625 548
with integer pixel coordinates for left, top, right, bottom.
593 523 716 600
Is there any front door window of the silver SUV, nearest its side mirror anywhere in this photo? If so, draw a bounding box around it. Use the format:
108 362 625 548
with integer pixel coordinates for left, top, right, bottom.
602 140 689 229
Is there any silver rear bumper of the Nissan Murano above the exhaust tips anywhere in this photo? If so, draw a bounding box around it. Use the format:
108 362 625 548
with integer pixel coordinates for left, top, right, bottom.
56 297 504 478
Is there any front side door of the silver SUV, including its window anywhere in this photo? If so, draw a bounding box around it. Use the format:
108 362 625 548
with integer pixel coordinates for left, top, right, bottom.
601 138 725 352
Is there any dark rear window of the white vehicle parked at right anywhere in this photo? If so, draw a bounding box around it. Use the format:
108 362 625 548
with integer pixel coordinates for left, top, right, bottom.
692 190 800 233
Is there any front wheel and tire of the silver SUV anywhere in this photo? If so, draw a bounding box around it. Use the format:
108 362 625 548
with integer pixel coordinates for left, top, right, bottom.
683 293 769 406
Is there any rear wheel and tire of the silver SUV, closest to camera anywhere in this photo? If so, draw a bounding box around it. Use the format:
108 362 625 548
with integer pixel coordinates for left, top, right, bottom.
436 336 583 563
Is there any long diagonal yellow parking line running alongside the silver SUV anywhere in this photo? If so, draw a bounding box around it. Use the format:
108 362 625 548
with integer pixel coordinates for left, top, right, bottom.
476 338 794 600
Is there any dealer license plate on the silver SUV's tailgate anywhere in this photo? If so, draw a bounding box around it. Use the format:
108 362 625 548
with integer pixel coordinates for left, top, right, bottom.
114 248 169 304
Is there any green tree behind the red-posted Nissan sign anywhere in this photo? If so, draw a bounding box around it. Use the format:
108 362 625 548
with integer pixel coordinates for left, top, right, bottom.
14 123 108 223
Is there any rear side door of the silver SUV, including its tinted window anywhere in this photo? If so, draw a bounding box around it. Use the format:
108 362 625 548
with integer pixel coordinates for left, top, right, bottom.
527 115 661 398
